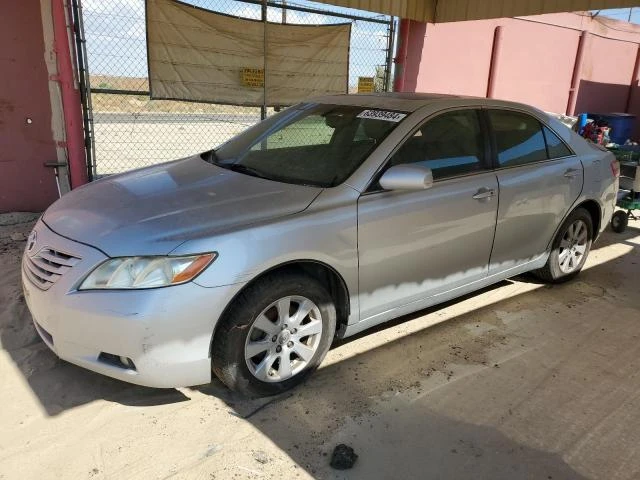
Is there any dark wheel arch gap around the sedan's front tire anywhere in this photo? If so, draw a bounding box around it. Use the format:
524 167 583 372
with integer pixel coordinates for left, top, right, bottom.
209 259 351 356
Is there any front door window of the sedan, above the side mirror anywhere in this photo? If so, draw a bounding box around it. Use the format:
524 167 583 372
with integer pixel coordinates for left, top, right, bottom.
387 110 484 180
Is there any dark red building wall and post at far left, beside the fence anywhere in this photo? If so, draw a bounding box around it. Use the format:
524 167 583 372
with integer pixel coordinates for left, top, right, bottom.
0 0 87 213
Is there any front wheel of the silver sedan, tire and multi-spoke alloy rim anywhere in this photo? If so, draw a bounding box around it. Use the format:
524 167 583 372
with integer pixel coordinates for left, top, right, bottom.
211 273 336 397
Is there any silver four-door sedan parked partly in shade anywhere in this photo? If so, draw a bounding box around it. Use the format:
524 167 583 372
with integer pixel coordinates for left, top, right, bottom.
23 94 618 396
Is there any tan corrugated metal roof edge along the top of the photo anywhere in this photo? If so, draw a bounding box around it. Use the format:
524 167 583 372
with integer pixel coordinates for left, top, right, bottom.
316 0 640 23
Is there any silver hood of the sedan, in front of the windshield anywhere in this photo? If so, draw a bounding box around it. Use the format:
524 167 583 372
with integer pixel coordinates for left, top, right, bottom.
43 156 322 256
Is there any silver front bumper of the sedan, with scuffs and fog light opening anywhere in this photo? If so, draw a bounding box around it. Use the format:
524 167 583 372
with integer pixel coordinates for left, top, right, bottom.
22 221 242 388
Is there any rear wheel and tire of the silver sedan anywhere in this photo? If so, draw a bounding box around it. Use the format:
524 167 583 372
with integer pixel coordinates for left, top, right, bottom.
533 208 593 283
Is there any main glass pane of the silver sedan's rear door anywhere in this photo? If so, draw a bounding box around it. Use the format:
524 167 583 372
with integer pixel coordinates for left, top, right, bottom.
489 110 547 167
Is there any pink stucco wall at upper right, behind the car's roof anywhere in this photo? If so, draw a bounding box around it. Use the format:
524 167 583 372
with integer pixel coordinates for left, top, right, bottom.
403 13 640 133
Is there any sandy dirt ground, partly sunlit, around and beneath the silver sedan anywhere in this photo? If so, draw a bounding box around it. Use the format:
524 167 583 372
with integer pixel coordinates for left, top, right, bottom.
0 215 640 480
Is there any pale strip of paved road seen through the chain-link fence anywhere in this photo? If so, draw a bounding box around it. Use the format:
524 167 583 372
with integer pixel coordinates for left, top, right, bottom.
93 112 260 124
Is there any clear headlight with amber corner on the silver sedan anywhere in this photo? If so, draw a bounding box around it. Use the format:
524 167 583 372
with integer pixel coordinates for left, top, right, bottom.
78 253 217 290
